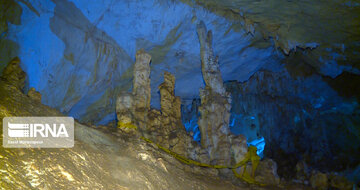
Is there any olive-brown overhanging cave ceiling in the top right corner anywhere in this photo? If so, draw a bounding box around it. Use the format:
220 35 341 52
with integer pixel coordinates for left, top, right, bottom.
186 0 360 77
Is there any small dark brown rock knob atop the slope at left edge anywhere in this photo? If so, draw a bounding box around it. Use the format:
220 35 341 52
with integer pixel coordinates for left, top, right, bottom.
2 57 26 90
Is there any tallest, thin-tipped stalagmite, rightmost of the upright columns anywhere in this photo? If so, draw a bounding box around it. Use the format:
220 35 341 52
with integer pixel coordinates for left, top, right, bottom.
197 22 231 165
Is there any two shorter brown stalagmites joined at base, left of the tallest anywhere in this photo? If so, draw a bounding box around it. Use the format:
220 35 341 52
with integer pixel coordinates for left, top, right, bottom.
116 51 191 155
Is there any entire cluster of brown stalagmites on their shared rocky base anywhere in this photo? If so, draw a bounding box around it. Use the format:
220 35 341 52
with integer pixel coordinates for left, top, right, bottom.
116 28 264 181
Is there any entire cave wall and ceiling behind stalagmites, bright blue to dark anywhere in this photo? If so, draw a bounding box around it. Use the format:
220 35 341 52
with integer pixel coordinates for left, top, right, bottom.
0 0 360 183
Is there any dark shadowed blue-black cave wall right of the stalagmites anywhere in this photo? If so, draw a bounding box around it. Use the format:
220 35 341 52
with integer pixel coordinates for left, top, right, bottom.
226 60 360 178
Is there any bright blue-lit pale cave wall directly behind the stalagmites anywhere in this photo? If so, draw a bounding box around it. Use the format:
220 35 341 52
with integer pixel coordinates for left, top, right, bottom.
8 0 277 124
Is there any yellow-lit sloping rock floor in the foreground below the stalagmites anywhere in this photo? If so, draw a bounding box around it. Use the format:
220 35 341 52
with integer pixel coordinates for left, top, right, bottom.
0 59 251 190
